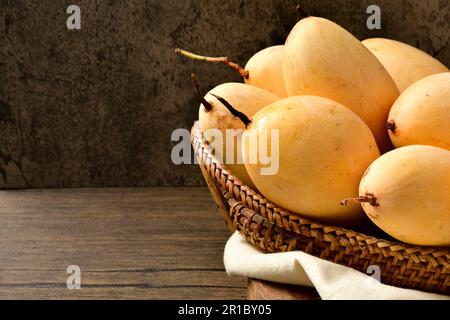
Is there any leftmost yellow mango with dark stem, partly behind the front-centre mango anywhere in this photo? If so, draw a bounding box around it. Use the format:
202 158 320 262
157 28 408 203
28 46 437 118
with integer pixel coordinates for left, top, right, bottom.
198 82 280 189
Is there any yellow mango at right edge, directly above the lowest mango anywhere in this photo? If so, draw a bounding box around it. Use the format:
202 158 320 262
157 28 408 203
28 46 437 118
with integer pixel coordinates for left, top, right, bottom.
387 72 450 150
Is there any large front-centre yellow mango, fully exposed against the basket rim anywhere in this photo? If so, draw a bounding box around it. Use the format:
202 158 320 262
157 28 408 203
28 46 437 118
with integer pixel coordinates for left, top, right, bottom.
242 96 380 226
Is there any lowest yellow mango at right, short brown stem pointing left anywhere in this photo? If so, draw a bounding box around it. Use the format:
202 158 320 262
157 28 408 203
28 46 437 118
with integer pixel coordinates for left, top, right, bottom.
352 145 450 246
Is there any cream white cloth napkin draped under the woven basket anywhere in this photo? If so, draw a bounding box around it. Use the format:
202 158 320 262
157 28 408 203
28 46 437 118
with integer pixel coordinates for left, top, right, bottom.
224 232 450 300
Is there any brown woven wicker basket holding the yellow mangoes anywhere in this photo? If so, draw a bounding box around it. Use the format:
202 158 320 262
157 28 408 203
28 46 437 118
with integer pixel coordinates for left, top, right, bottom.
191 122 450 295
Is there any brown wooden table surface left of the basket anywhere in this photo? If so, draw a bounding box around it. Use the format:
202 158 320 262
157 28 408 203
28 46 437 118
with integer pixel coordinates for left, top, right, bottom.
0 188 247 299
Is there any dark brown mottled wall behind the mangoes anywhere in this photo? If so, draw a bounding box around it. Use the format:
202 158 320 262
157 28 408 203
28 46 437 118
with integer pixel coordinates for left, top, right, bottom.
0 0 450 188
